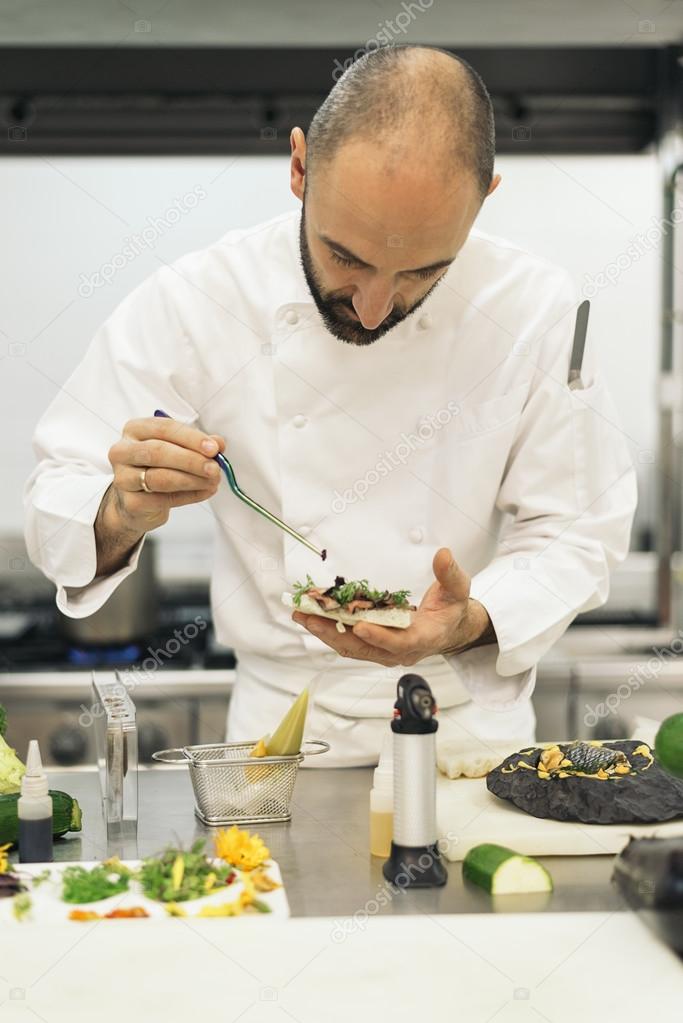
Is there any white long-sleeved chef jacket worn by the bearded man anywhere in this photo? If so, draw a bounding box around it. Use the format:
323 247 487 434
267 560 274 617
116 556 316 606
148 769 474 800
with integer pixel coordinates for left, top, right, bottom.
26 212 636 748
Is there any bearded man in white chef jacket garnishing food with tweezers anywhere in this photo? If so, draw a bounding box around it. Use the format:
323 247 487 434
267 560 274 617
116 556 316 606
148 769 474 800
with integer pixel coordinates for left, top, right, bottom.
26 46 636 766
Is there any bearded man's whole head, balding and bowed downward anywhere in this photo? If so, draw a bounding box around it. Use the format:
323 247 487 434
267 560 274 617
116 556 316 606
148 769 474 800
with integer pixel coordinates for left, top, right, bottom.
290 46 499 345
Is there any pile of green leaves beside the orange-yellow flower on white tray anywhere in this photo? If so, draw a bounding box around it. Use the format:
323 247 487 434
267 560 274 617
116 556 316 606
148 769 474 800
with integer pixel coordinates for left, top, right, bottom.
140 839 234 902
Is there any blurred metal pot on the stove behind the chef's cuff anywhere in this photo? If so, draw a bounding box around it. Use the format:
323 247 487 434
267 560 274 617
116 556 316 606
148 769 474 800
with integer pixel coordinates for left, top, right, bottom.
59 538 158 647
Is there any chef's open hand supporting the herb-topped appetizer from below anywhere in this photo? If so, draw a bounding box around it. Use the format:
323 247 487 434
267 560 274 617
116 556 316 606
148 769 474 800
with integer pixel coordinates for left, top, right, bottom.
291 547 496 668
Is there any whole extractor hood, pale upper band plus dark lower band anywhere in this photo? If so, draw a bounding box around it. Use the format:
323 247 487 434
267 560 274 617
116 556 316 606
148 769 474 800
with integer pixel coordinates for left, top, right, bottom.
0 0 683 155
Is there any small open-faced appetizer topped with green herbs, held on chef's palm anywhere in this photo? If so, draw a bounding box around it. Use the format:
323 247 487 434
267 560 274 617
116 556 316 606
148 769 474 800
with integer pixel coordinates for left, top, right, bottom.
282 576 416 632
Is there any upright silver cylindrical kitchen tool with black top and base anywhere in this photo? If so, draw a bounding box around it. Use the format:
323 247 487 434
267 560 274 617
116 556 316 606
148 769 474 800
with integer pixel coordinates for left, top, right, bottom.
382 675 448 888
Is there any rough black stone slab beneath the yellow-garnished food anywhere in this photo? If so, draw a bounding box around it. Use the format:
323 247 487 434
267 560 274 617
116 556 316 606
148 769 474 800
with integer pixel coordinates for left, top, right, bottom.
487 740 683 825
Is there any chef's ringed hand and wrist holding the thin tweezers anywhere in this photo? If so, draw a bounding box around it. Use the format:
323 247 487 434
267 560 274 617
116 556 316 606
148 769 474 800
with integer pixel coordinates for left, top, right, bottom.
95 416 225 575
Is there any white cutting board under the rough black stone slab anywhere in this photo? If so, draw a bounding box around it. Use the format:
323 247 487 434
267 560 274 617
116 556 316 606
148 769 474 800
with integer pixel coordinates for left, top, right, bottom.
437 774 683 860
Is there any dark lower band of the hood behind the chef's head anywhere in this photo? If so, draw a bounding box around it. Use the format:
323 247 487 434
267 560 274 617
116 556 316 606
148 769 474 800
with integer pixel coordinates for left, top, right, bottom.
0 45 670 157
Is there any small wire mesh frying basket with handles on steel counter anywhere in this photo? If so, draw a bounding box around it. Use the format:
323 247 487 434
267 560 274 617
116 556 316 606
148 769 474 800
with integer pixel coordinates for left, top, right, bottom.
152 739 329 827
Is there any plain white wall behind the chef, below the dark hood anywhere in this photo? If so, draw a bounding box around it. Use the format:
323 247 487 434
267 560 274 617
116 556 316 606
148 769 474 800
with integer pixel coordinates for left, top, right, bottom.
0 155 659 568
